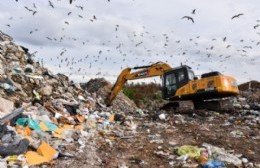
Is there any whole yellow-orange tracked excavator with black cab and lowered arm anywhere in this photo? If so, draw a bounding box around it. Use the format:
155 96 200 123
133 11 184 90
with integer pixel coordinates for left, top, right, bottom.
107 62 239 111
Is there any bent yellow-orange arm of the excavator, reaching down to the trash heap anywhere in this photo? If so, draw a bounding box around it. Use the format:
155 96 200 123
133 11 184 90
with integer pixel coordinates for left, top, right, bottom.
107 62 172 105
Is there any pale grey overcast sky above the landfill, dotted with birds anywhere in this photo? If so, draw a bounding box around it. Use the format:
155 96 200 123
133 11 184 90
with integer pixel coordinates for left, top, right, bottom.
0 0 260 83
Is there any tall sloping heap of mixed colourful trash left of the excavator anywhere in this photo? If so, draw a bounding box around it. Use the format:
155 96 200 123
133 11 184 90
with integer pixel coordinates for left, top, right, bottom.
0 32 136 167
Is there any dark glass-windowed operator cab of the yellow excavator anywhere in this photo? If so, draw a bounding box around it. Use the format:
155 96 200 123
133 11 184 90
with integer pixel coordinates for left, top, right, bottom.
162 65 195 100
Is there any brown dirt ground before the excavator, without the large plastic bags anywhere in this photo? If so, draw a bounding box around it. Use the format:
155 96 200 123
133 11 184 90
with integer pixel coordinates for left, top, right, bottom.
97 112 260 168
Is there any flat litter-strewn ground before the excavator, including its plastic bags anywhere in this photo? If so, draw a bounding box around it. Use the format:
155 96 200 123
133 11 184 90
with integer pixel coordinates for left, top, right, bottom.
98 107 260 168
